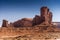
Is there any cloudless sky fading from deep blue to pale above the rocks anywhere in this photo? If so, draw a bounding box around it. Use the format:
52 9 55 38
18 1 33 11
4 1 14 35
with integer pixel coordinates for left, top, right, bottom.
0 0 60 25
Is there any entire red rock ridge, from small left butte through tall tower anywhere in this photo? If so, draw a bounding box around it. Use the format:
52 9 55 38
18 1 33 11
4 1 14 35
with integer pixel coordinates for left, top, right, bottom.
2 7 52 27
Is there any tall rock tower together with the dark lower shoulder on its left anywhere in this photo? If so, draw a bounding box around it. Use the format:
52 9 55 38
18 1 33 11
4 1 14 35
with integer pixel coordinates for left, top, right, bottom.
33 7 52 25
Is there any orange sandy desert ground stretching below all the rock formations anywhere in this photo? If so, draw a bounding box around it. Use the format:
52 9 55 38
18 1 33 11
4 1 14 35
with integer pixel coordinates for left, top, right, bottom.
0 26 60 40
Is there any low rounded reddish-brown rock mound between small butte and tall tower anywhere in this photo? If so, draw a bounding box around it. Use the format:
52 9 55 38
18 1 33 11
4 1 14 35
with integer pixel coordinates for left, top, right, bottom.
13 18 32 27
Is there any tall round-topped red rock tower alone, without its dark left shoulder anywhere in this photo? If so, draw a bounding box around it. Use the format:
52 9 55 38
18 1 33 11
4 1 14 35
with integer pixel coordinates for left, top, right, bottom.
41 7 52 25
